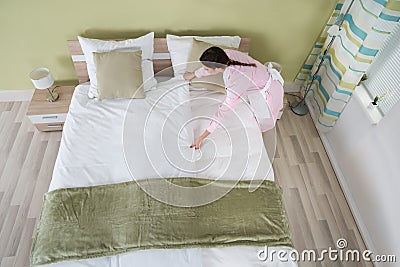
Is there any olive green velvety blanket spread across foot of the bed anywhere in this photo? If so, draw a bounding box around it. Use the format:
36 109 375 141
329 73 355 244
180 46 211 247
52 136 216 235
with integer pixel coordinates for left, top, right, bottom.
31 178 292 266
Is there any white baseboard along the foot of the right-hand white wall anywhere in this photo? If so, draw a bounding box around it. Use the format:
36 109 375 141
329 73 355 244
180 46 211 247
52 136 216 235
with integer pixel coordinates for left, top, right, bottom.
306 99 382 267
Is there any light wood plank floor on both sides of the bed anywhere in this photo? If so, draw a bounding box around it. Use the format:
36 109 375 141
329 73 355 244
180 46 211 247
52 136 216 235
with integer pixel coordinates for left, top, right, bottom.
0 102 372 267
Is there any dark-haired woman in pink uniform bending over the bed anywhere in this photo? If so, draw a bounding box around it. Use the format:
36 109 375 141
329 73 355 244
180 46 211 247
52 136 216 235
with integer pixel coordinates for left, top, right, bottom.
183 47 283 149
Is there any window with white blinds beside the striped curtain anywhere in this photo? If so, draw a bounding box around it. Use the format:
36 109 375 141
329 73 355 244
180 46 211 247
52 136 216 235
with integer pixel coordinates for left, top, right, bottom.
363 25 400 116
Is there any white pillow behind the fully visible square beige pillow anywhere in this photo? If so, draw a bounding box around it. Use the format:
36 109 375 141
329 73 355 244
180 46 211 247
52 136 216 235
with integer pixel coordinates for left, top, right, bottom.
78 32 157 98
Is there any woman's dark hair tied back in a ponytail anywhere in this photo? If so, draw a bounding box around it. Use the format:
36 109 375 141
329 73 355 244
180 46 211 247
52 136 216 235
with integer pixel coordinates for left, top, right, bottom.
200 46 256 69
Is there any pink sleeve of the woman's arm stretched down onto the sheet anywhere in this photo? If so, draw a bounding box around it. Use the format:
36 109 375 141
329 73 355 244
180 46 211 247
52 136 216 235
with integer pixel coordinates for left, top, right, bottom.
207 89 240 133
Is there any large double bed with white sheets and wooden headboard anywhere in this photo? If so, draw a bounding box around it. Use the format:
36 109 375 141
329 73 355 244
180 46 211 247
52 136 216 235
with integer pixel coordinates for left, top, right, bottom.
30 33 297 267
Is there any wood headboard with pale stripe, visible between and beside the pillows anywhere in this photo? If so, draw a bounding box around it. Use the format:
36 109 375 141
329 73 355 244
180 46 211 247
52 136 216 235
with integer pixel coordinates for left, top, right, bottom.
68 38 250 83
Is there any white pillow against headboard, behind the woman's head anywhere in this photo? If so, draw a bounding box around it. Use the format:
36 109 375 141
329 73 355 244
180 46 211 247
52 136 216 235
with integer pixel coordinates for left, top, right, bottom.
167 34 241 76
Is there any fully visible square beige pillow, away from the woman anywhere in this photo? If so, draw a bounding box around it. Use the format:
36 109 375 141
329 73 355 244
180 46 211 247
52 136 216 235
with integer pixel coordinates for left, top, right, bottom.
93 50 145 100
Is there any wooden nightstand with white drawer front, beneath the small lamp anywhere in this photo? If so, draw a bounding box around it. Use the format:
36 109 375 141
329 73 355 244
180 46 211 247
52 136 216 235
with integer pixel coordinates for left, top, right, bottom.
26 86 75 132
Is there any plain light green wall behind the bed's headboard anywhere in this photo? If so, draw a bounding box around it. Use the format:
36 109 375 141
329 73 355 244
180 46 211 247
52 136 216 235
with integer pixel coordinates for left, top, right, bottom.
0 0 336 90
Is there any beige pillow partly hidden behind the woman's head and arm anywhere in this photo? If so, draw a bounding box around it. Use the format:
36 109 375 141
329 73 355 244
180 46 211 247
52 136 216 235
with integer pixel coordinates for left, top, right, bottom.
186 38 236 94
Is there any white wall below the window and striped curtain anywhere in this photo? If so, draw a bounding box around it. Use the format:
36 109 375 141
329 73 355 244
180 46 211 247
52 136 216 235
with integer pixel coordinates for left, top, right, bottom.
325 93 400 266
